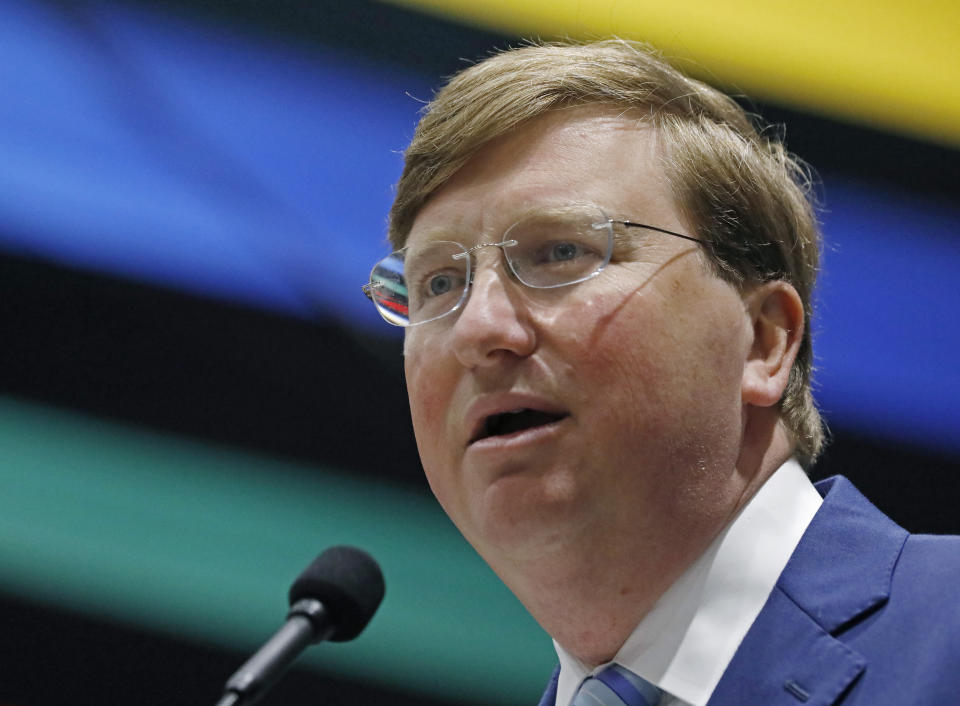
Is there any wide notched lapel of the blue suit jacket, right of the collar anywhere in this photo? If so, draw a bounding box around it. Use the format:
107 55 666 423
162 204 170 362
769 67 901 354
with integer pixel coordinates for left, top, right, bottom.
709 478 907 706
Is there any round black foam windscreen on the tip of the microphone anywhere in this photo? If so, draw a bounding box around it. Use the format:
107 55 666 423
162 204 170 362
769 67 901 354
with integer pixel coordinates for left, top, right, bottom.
290 546 384 642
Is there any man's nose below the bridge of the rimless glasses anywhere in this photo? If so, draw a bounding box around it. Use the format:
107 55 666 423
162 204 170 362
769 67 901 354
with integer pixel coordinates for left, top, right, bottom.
452 251 536 368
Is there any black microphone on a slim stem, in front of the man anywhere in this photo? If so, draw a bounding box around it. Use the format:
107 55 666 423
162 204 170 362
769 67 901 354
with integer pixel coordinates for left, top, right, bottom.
217 547 384 706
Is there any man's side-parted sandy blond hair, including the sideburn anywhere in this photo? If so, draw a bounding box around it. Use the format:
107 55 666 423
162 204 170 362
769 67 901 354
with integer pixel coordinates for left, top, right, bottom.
389 39 824 467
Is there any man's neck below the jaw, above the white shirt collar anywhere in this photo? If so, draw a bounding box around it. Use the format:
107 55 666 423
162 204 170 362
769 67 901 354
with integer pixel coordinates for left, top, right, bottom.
488 410 792 668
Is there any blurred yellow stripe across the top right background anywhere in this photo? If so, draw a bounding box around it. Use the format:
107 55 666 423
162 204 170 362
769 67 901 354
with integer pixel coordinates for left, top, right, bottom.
380 0 960 146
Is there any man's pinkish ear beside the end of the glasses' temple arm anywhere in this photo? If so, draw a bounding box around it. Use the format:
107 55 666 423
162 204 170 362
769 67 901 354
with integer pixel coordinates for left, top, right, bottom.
741 280 805 407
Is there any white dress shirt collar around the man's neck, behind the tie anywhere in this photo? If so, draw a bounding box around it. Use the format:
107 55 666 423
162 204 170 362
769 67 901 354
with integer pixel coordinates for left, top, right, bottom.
554 459 822 706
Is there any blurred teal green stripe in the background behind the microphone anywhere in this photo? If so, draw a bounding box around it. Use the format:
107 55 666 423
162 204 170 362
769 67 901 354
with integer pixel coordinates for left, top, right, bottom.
0 398 554 703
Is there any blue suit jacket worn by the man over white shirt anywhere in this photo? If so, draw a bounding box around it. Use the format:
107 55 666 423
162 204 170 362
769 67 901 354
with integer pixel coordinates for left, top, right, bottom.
540 476 960 706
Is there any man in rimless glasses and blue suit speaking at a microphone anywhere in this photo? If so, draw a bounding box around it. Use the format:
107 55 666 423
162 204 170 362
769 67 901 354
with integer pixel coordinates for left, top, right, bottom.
367 40 960 706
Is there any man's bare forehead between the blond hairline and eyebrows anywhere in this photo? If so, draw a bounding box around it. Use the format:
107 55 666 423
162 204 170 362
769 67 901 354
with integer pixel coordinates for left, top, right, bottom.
408 105 683 243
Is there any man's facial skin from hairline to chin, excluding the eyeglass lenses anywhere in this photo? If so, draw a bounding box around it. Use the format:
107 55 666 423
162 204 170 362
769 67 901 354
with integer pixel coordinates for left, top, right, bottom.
404 106 751 571
